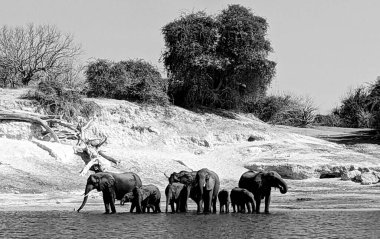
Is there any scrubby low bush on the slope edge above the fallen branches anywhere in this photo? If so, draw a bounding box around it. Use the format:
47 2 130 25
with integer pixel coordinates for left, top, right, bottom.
25 80 100 121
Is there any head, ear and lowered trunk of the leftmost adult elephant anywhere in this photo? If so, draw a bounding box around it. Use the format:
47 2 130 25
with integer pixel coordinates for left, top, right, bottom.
77 173 115 212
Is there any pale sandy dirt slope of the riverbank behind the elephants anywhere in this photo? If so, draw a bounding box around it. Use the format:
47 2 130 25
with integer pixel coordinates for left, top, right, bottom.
0 92 380 211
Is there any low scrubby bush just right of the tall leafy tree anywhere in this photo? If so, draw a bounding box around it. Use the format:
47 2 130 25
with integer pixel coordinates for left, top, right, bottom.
245 95 316 127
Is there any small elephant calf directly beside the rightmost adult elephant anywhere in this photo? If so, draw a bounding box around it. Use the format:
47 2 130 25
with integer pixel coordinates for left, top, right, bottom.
231 187 255 213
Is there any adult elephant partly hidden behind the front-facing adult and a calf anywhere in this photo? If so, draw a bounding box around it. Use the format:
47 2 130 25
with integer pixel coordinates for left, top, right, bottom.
164 170 197 212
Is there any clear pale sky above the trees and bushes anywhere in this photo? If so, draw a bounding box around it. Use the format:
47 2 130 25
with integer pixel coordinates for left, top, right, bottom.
0 0 380 113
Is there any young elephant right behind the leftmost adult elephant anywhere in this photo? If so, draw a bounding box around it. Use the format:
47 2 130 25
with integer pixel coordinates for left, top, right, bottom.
120 184 161 213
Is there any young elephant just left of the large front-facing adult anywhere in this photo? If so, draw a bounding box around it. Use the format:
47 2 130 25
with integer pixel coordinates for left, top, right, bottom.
165 183 189 213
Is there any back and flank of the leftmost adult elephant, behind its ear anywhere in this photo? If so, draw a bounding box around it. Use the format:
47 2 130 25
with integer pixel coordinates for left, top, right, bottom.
111 172 142 200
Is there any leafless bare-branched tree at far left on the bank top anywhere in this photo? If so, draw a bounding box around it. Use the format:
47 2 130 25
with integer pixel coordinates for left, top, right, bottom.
0 24 81 87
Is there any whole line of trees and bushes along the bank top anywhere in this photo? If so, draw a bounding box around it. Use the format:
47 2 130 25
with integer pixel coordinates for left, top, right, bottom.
0 5 380 128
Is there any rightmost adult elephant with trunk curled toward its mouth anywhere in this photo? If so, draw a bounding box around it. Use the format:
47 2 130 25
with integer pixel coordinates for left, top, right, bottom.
239 171 288 213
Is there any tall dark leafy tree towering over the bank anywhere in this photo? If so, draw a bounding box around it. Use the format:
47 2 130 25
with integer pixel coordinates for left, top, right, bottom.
162 5 276 108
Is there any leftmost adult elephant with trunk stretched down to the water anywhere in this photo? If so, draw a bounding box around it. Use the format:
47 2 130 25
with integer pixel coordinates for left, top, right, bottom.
77 172 142 213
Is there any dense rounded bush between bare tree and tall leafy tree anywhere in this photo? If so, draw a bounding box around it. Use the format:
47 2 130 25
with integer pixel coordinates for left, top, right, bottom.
85 60 168 104
